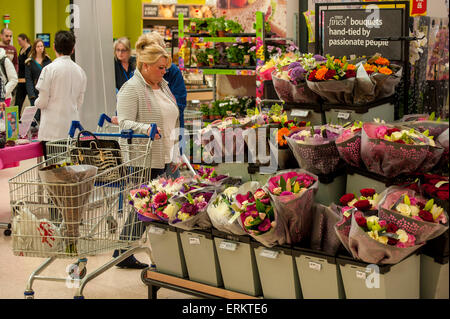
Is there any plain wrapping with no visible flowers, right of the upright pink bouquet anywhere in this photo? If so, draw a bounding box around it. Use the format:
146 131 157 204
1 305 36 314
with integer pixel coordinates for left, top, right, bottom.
311 203 342 255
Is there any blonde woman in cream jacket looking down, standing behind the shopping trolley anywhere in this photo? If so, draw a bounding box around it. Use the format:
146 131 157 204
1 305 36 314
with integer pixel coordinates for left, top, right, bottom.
113 35 179 269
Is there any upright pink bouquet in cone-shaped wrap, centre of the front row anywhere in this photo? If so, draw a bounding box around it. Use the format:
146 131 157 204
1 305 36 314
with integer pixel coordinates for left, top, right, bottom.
266 169 319 244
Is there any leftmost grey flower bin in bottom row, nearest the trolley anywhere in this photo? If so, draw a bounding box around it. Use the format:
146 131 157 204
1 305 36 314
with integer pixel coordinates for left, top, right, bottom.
148 221 188 278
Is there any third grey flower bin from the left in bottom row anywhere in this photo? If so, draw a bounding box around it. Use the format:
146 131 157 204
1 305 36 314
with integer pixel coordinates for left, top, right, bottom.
212 229 262 296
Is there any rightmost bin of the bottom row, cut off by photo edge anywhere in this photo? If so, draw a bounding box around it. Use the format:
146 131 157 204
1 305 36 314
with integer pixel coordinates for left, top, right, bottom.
420 229 449 299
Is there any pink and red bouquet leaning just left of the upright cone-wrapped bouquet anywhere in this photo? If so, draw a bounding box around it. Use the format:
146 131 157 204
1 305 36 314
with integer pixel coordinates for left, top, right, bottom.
234 182 286 247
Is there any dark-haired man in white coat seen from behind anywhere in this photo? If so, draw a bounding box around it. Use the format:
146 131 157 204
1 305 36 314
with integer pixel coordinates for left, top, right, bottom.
35 31 87 145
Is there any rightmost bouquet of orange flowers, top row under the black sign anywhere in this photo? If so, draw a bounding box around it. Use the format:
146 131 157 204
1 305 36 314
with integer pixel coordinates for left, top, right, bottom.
364 55 402 100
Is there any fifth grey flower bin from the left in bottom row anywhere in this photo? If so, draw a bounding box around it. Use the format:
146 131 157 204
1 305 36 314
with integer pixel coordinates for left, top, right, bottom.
293 247 345 299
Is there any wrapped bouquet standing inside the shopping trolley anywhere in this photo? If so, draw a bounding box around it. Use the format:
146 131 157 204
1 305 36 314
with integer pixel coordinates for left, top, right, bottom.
39 164 97 254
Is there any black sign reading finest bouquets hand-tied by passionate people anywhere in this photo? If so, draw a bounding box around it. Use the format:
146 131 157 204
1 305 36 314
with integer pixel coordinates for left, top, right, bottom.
323 9 403 60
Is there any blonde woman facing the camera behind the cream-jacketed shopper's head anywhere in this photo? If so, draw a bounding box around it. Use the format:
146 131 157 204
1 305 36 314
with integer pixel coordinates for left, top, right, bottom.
114 38 136 92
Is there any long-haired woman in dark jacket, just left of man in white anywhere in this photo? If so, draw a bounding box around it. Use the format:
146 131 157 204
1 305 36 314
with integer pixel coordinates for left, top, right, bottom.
25 39 52 125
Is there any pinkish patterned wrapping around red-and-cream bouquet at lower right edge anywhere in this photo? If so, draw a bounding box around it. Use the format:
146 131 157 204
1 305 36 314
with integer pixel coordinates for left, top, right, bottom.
378 186 448 243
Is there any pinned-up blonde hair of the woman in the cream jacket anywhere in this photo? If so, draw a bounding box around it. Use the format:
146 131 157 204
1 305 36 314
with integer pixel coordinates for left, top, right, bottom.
136 32 172 71
